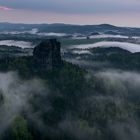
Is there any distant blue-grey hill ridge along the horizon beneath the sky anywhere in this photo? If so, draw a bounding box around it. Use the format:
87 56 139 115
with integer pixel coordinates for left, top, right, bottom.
0 23 140 35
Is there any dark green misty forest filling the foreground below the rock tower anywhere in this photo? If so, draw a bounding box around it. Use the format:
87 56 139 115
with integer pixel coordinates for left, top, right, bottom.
0 57 140 140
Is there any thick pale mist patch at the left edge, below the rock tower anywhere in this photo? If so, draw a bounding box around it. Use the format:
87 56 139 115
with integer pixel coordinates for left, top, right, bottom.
0 72 45 135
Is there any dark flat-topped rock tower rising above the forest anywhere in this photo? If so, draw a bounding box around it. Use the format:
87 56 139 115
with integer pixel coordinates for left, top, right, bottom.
33 39 62 72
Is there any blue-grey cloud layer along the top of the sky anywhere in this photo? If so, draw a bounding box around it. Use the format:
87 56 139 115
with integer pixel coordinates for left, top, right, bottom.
0 0 140 14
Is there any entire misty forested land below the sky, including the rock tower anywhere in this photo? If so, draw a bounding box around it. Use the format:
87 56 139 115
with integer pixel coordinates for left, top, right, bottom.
0 24 140 140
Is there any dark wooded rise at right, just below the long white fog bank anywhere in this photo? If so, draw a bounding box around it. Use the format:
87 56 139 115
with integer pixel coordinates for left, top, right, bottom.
91 47 140 71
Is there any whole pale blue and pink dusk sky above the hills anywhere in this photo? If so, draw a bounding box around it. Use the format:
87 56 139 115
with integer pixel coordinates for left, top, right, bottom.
0 0 140 27
